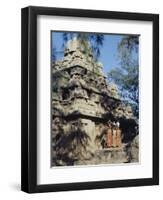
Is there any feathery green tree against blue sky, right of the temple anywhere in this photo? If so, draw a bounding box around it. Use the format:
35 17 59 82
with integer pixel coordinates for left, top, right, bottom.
108 36 139 117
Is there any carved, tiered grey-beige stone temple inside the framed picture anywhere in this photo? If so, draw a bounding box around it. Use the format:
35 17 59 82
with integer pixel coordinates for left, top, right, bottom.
51 38 138 166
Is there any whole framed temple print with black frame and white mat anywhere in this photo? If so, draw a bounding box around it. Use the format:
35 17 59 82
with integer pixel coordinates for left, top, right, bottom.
21 6 159 193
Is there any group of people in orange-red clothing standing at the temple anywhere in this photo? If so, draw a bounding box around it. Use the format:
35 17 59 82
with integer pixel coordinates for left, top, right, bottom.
105 121 122 148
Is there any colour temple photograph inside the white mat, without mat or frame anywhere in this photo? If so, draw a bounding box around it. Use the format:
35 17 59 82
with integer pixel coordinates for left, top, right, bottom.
49 30 140 167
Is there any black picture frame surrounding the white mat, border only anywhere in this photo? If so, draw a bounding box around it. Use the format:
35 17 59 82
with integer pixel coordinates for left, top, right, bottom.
21 6 159 193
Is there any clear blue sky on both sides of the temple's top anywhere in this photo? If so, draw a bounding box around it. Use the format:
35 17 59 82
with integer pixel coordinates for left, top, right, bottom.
52 32 123 74
